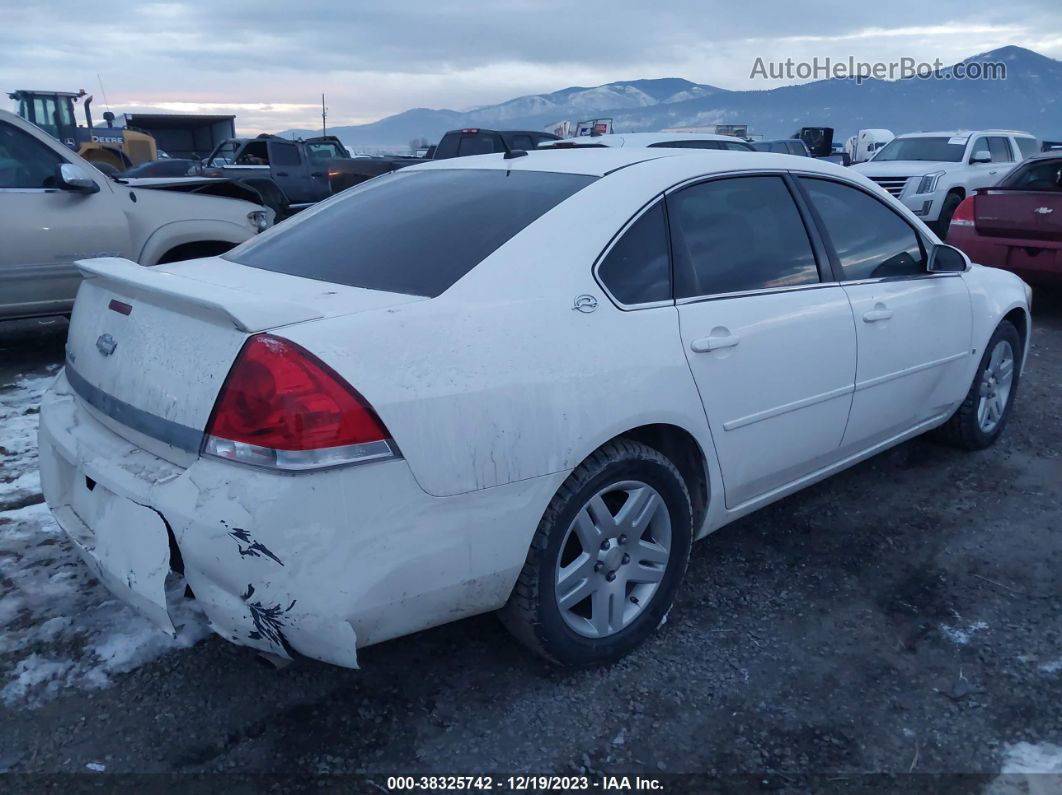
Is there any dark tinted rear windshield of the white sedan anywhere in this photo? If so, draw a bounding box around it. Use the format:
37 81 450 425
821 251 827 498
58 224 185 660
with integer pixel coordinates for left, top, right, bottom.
225 169 597 298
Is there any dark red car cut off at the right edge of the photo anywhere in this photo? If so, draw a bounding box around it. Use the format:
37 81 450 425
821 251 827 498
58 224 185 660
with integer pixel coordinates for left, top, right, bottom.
947 152 1062 287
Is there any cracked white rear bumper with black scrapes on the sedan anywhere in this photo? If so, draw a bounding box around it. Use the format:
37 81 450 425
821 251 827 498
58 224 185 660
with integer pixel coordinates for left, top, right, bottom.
39 374 564 668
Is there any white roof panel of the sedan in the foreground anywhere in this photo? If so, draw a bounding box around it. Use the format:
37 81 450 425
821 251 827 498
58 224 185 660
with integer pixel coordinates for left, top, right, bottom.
404 146 851 176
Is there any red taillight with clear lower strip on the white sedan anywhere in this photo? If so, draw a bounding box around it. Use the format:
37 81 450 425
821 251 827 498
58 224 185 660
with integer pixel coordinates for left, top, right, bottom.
203 334 396 469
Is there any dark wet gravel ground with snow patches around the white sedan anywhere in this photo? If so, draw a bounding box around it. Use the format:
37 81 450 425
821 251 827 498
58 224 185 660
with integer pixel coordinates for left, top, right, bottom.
0 295 1062 792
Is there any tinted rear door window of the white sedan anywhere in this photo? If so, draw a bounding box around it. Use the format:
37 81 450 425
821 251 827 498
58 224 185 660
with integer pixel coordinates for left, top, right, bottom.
668 176 819 298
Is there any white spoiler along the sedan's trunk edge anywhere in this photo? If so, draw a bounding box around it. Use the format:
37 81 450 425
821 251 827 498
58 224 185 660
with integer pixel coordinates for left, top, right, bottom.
74 257 324 333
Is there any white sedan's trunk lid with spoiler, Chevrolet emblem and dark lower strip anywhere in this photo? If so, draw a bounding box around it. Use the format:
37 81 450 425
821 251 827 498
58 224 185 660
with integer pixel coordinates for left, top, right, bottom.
67 258 423 464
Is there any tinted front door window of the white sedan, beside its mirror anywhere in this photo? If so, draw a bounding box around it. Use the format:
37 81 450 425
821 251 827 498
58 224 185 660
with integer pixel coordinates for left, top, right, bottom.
800 177 926 281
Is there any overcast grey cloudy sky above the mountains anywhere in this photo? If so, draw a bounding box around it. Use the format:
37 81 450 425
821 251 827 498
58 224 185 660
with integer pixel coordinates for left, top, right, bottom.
0 0 1062 132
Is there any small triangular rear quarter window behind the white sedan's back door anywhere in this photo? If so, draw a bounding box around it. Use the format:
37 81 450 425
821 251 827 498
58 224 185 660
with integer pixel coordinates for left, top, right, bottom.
598 201 671 306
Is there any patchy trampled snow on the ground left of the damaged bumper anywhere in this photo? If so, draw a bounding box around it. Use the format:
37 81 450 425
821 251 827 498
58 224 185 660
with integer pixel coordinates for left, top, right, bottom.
0 367 208 705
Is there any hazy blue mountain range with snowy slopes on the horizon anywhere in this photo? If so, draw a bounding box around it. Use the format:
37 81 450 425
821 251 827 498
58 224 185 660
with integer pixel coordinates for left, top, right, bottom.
279 47 1062 152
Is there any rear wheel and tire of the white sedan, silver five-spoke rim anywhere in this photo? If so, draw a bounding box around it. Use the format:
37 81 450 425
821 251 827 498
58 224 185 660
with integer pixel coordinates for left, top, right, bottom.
499 438 692 667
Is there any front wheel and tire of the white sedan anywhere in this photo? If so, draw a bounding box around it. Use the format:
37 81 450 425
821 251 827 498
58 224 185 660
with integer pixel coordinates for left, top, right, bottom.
938 321 1023 450
